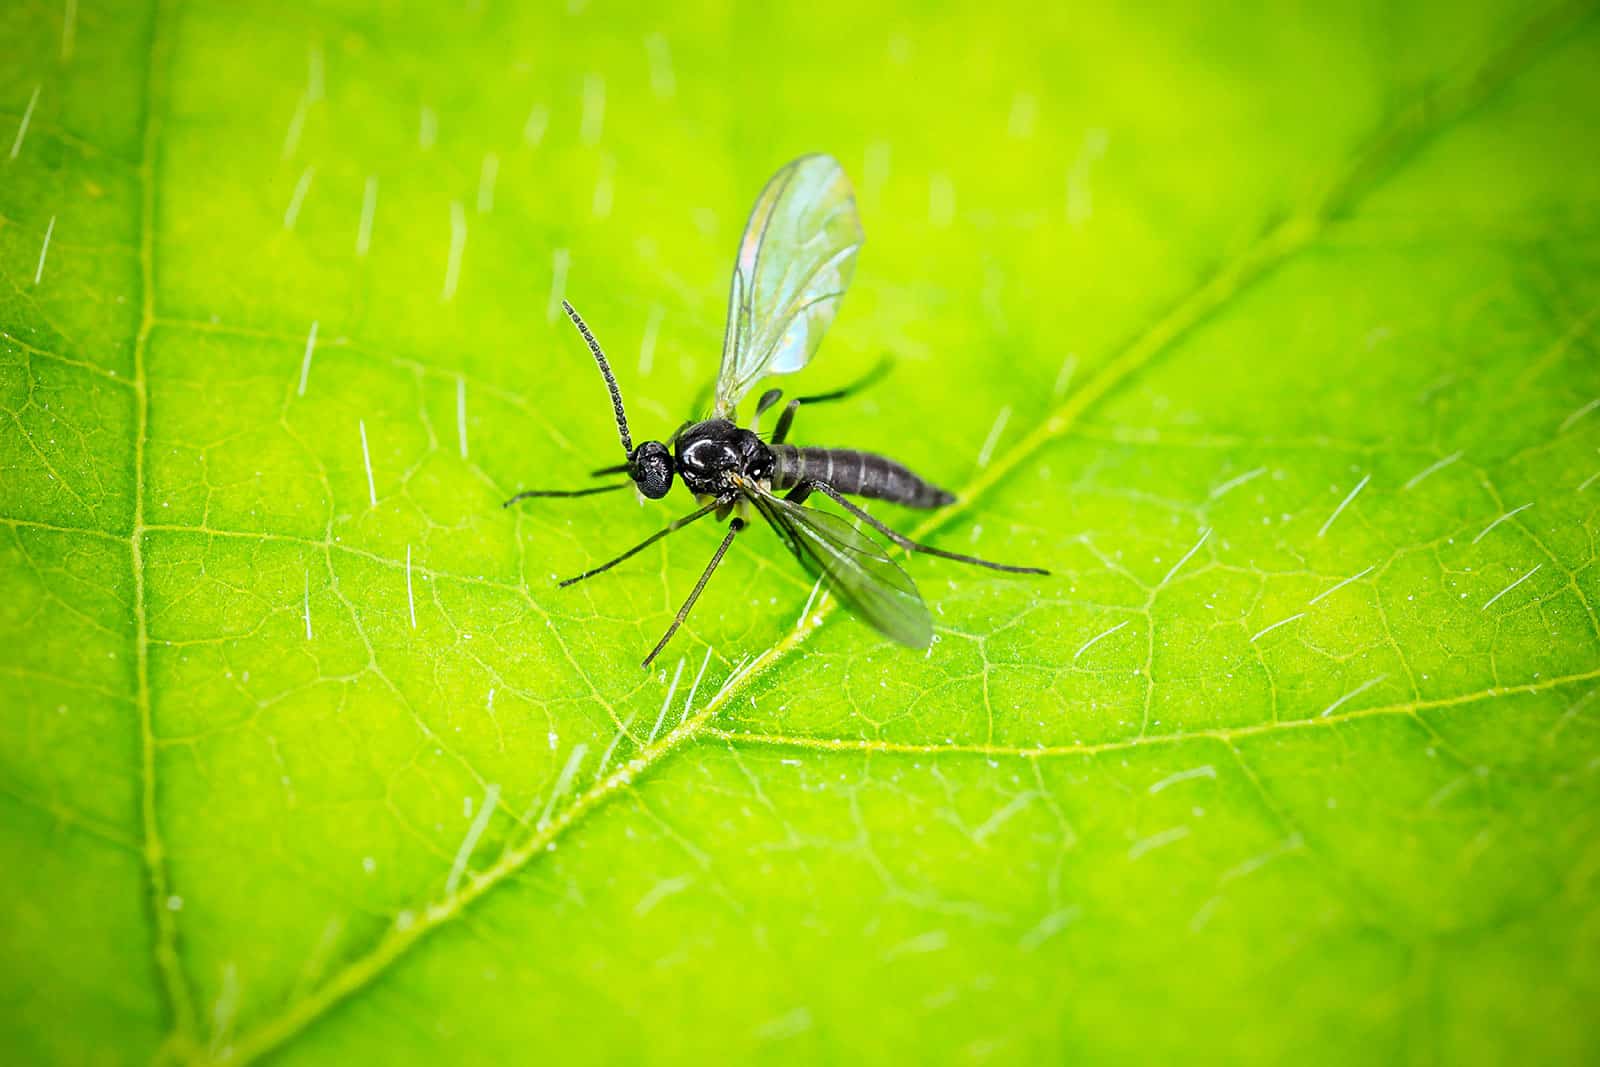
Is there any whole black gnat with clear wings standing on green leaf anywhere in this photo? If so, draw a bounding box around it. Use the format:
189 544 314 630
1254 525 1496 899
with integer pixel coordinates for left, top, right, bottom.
506 155 1046 667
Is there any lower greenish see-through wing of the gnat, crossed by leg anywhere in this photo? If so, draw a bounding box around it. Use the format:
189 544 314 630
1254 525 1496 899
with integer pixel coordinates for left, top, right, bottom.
746 488 933 648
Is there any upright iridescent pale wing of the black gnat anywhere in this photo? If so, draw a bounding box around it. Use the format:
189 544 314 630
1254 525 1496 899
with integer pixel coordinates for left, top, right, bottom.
717 155 862 418
